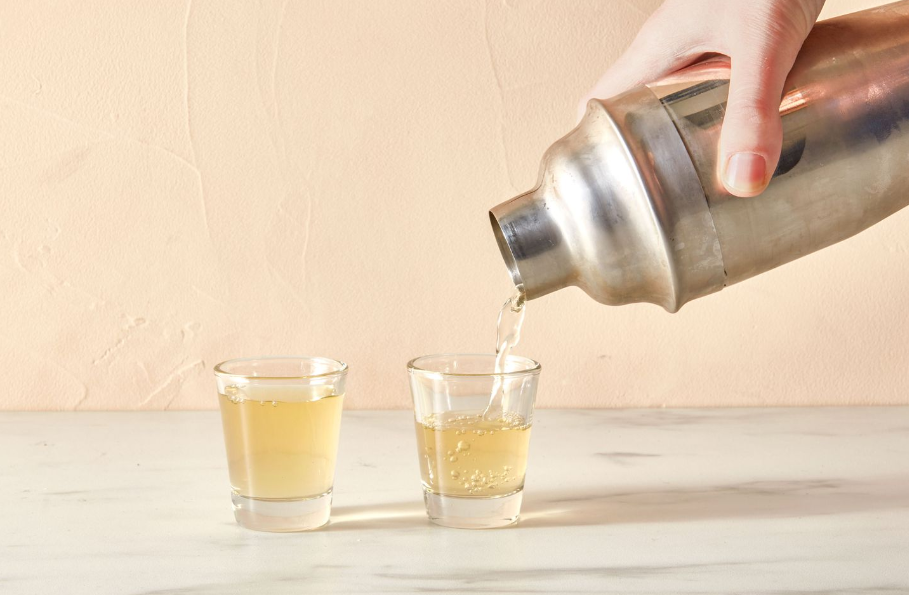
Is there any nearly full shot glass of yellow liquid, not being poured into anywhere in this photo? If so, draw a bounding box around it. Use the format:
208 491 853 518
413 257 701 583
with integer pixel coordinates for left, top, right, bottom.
215 357 347 532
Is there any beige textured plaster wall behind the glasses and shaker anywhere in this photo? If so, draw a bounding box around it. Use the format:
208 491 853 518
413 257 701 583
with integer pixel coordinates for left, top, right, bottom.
0 0 909 409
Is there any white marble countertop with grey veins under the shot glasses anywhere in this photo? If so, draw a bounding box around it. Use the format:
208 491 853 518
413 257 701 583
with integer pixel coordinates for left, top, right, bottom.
0 407 909 595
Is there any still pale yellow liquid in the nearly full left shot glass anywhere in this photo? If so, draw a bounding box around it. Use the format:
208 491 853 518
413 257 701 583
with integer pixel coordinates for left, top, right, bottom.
219 387 344 499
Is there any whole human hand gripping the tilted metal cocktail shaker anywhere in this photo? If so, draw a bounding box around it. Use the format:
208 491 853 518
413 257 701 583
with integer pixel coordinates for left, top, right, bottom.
580 0 824 196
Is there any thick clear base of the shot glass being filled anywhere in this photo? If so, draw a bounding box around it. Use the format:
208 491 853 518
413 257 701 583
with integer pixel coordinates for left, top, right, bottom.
423 487 524 529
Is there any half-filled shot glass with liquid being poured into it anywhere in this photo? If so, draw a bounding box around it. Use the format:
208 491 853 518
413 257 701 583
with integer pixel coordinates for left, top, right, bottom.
407 354 540 529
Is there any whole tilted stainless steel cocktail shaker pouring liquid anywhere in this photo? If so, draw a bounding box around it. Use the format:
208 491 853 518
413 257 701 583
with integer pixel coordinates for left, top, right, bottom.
490 2 909 312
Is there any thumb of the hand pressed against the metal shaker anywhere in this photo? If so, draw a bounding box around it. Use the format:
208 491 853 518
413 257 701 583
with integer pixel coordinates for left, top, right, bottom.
717 47 798 197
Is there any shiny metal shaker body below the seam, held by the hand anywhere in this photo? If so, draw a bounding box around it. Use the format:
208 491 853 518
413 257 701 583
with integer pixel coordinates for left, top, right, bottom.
649 2 909 284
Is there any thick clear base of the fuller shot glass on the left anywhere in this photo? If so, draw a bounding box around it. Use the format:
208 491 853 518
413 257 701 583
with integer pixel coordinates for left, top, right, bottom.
230 490 331 533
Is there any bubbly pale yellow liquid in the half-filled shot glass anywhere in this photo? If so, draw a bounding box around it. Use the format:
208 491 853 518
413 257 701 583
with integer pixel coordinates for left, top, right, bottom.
417 412 530 498
